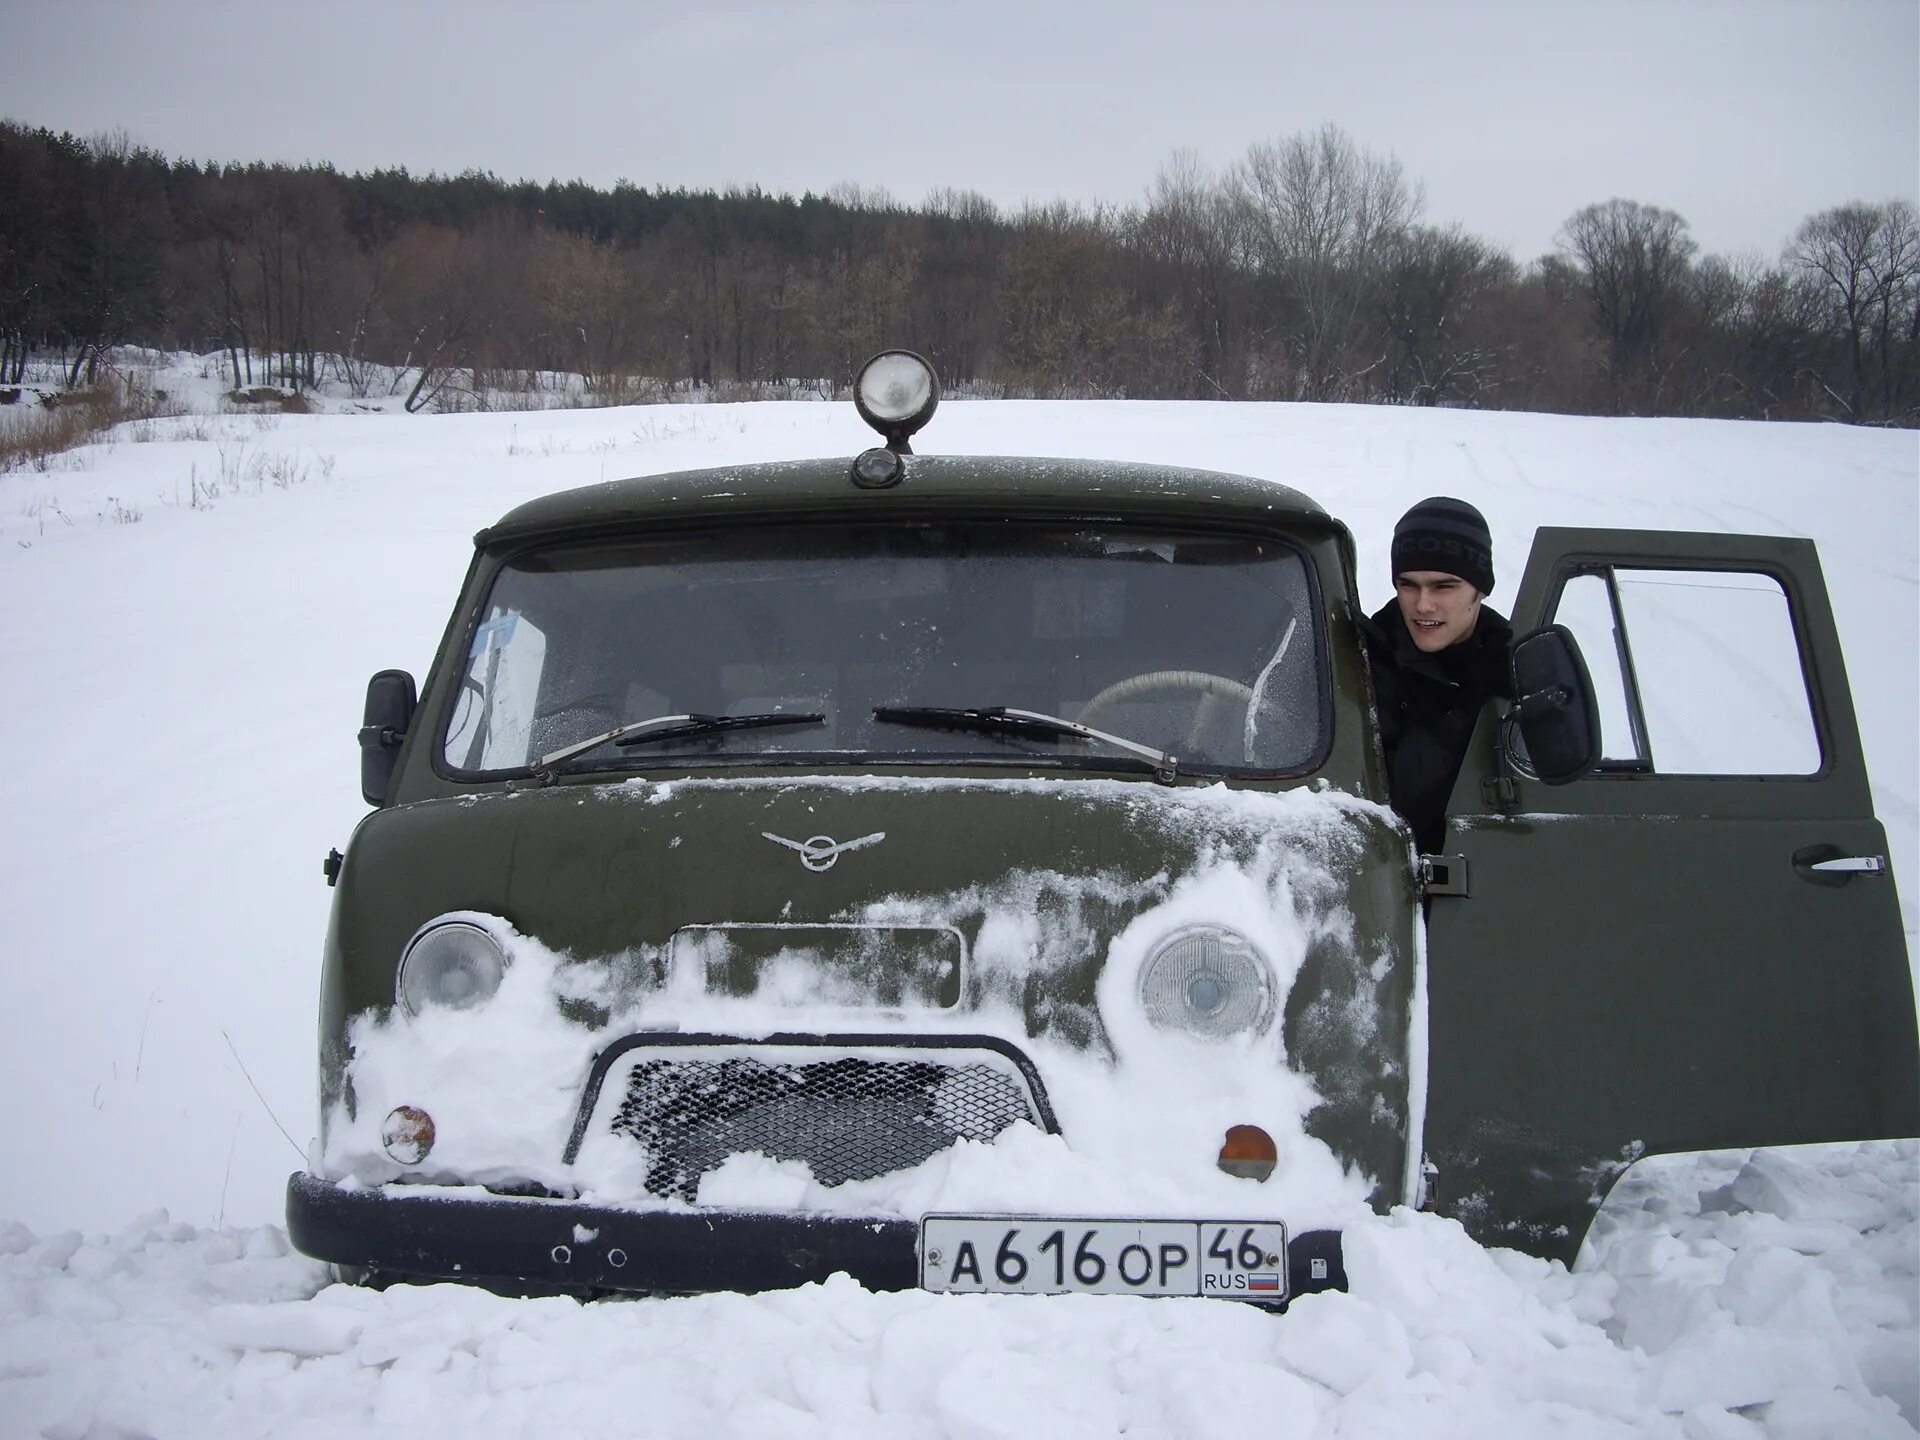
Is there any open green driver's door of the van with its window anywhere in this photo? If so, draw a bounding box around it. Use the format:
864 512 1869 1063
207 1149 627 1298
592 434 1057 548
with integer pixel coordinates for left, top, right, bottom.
1425 528 1920 1263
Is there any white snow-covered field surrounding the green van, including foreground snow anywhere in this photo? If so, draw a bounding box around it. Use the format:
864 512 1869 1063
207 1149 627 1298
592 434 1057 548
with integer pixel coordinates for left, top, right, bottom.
0 362 1920 1440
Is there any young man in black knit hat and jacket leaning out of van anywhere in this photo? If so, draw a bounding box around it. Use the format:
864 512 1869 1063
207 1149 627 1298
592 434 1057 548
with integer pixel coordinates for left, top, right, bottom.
1369 495 1513 854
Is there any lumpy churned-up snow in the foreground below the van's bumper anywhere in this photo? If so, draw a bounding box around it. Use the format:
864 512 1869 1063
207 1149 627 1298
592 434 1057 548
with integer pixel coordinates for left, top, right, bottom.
0 1140 1920 1440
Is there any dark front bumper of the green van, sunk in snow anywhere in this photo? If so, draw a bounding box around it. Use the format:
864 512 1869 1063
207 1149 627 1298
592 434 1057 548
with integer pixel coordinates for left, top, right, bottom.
286 1173 1346 1298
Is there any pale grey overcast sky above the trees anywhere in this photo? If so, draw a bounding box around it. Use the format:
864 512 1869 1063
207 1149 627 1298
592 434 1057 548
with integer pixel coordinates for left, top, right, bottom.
0 0 1920 259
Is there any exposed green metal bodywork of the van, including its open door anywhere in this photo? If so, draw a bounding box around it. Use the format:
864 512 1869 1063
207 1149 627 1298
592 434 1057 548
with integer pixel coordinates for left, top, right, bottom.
307 457 1920 1258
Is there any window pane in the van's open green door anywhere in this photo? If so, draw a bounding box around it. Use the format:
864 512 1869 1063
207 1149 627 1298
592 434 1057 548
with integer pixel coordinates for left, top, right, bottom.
1549 566 1820 776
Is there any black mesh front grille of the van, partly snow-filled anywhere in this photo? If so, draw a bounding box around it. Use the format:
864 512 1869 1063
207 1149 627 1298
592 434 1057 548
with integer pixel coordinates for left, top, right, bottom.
611 1052 1050 1200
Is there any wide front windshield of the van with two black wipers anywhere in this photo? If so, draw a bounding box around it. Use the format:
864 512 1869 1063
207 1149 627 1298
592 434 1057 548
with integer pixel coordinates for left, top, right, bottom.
442 522 1325 776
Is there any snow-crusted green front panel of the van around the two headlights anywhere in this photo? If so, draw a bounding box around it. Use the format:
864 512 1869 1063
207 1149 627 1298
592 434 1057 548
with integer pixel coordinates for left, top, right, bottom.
328 776 1413 1221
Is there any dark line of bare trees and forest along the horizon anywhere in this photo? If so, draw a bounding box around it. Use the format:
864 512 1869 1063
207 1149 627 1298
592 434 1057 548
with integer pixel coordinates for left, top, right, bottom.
0 121 1920 424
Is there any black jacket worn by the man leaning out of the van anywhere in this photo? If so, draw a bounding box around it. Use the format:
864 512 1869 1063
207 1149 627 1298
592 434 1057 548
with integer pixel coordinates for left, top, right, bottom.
1367 601 1513 854
